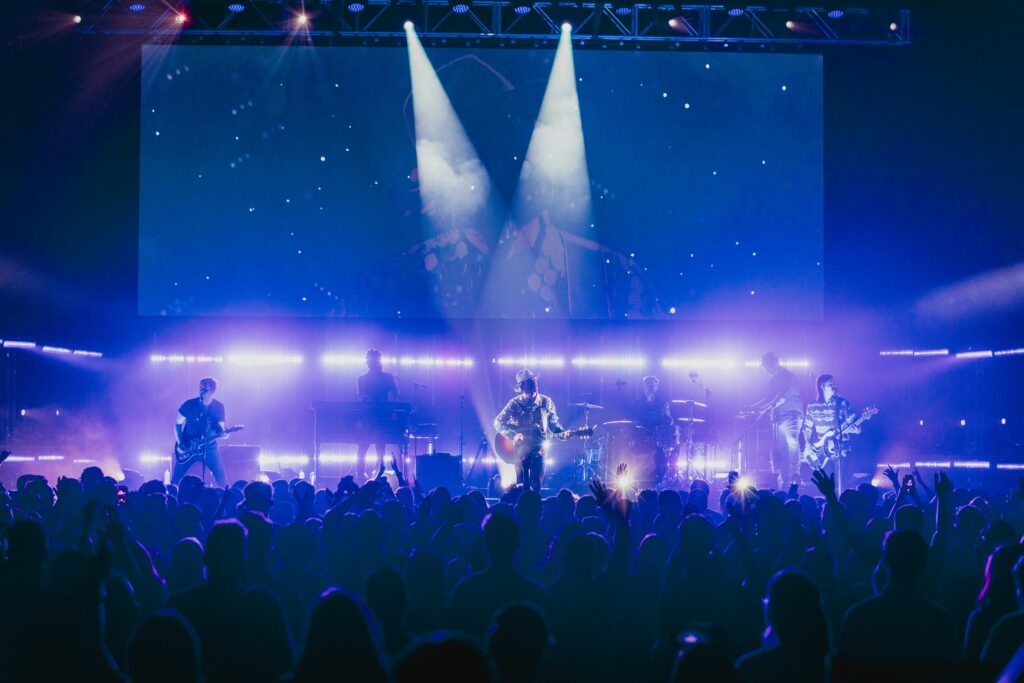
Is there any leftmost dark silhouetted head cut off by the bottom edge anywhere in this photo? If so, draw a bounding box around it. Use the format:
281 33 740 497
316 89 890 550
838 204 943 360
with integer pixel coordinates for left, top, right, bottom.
127 610 199 683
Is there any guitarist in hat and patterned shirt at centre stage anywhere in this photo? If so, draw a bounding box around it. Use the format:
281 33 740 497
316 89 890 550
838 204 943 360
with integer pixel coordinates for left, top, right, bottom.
495 369 568 494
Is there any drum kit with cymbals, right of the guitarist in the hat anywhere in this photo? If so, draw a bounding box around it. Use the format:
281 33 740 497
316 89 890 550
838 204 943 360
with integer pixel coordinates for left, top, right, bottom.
569 399 715 488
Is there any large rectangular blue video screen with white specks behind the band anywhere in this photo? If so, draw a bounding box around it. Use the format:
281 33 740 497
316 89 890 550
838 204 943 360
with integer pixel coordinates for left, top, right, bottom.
138 46 824 321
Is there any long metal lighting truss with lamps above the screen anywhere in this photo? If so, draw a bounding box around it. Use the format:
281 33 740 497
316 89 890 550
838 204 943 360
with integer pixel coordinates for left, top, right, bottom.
75 0 910 49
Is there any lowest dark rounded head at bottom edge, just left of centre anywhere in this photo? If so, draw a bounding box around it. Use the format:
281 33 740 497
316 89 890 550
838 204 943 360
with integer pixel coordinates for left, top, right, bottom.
394 632 494 683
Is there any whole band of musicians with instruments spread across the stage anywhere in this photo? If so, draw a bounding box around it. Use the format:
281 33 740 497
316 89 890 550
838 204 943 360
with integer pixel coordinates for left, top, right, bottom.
171 349 878 492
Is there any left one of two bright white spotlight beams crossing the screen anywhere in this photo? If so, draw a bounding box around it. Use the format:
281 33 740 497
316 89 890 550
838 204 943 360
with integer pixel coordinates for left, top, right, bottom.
406 22 490 227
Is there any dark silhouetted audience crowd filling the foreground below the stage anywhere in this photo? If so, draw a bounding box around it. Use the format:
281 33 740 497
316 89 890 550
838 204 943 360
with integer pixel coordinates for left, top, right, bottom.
0 454 1024 683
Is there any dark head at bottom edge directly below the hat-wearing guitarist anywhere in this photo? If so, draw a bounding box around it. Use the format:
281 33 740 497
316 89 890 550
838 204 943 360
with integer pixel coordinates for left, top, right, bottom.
486 603 551 683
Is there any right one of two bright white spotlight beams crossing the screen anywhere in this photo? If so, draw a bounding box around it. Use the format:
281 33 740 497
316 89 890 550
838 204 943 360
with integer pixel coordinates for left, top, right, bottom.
516 26 590 227
